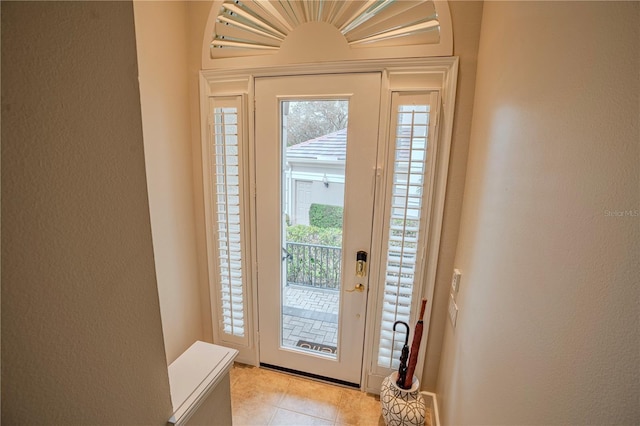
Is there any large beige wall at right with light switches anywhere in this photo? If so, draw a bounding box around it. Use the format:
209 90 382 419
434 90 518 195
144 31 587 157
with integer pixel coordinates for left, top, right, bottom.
438 2 640 424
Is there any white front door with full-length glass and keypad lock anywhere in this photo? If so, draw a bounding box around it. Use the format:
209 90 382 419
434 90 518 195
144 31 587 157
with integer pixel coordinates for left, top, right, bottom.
255 73 381 385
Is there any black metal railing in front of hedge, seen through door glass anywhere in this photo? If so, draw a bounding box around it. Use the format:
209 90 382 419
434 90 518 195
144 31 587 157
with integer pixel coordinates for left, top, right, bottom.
284 242 342 290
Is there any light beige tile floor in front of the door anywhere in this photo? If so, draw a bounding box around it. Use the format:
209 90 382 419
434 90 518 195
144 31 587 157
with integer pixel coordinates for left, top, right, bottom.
231 364 384 426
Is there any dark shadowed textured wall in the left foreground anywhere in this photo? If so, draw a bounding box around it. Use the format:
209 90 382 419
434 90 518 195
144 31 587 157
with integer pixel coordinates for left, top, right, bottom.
1 2 172 425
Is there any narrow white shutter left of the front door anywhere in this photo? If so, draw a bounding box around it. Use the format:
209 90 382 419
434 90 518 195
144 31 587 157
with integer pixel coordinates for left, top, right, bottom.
208 96 248 344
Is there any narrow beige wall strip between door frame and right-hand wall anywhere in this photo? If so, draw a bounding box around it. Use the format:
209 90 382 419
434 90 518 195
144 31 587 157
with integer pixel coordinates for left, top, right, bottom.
420 1 482 391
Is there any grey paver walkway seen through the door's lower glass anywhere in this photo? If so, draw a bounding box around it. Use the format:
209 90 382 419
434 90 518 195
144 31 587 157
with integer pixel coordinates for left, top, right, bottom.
282 285 340 347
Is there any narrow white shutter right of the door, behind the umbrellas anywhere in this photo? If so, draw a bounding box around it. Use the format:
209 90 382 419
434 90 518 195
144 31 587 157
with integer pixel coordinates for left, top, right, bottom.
377 93 433 369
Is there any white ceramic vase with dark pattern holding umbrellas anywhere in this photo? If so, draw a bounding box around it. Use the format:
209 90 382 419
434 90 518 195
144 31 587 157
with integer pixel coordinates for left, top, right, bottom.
380 372 427 426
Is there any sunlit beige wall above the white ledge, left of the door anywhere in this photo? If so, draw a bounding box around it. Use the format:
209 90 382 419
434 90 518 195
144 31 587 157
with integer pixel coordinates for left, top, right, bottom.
133 1 203 363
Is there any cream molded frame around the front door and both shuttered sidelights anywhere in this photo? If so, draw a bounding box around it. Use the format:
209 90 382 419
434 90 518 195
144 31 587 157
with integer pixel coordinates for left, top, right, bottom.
199 56 459 393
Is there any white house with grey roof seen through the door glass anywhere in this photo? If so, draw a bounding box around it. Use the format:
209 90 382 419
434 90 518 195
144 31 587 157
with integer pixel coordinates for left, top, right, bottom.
284 129 347 225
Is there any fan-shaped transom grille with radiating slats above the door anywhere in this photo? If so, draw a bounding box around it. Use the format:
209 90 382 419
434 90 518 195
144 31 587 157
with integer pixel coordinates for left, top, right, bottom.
210 0 440 58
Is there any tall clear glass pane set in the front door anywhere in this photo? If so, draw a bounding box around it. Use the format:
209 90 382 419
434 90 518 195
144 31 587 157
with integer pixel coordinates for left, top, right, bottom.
280 99 349 358
